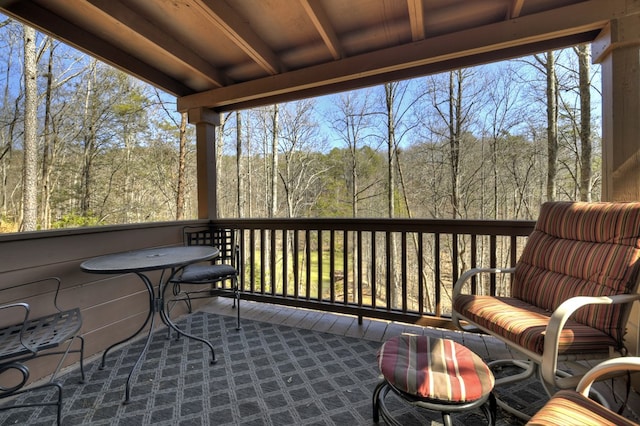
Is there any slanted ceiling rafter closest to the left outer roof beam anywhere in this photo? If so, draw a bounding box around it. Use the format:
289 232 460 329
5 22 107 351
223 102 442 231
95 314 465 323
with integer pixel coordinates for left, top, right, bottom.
89 0 230 87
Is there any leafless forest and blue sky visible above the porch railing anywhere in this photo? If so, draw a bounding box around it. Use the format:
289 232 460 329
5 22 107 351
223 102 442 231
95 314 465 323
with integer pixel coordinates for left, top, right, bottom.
0 17 601 232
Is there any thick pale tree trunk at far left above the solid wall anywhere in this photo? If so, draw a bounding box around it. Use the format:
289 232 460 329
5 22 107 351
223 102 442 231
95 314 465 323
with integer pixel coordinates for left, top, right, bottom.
20 25 38 231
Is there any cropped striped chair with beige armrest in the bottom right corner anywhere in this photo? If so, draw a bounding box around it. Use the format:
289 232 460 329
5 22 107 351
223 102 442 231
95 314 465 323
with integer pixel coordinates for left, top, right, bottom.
527 357 640 426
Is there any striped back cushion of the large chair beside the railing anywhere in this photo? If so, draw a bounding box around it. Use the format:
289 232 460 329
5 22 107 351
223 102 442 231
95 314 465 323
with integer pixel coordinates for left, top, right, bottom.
511 202 640 345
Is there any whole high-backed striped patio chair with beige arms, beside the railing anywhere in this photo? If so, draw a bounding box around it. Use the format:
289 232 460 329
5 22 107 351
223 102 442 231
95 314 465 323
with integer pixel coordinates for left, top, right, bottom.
453 202 640 417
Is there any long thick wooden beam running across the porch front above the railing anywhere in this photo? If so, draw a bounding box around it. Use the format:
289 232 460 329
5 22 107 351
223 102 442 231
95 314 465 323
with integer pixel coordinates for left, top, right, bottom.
178 0 619 111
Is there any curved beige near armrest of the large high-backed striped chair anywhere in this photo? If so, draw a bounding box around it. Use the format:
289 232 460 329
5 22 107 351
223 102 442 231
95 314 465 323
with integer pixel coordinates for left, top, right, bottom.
541 294 640 383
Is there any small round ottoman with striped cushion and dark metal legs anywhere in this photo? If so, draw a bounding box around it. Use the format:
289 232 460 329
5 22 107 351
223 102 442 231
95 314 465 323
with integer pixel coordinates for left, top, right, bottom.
373 335 496 426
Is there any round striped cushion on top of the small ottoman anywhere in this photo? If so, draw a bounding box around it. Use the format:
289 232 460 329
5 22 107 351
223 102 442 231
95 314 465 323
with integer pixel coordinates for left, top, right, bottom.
378 335 494 403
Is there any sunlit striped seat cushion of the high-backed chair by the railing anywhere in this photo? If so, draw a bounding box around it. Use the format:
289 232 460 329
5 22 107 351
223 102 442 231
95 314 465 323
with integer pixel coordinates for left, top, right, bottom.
454 295 616 355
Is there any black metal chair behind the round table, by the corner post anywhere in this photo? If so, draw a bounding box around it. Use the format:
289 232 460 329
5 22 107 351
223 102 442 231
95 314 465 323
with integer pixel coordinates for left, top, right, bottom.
169 226 240 330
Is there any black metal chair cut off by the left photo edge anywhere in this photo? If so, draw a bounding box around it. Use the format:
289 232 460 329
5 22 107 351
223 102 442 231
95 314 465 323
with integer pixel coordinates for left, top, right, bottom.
0 277 84 424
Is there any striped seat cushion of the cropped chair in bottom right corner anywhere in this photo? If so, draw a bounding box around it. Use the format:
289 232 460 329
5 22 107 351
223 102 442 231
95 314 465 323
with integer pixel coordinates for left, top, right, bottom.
527 390 637 426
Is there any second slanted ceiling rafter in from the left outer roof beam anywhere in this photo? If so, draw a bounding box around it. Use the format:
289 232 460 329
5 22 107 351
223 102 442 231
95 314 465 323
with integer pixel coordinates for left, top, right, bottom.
195 0 285 75
